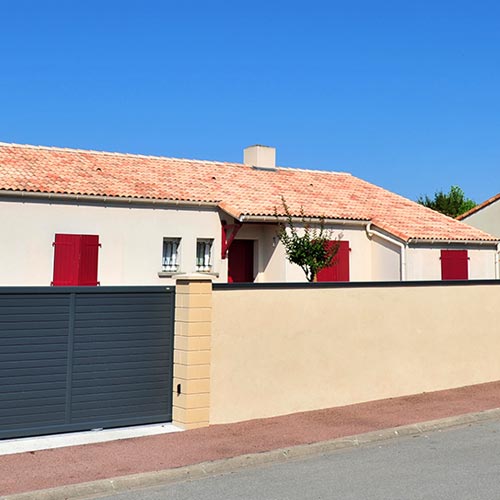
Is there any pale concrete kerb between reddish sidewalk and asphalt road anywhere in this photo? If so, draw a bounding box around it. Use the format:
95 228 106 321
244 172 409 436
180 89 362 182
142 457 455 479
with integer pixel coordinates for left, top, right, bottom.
0 408 500 500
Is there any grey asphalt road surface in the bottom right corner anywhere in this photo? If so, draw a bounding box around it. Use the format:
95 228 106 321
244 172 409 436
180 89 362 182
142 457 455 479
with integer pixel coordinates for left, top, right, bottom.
94 422 500 500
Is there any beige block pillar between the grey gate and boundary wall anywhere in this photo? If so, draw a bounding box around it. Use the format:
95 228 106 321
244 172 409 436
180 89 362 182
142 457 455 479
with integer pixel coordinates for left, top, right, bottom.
173 274 212 429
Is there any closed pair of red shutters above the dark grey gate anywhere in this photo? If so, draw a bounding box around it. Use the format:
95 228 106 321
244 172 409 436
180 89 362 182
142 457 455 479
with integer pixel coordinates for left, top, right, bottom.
51 234 101 286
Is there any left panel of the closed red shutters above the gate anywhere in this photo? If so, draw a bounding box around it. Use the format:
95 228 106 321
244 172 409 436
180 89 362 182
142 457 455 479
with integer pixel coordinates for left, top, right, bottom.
52 234 80 286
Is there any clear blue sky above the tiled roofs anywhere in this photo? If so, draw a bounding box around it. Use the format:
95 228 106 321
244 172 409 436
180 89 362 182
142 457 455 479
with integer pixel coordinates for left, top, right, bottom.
0 0 500 202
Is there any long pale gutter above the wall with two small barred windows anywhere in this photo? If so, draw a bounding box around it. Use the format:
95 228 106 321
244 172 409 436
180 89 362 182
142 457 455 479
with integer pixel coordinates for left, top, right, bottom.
0 189 218 208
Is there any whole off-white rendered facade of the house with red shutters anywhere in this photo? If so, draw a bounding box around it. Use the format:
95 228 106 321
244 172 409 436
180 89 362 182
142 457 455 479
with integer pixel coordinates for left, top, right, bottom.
0 198 497 286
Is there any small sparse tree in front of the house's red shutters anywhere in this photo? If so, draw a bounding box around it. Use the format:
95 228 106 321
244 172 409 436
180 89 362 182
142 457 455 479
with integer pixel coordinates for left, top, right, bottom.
274 197 341 281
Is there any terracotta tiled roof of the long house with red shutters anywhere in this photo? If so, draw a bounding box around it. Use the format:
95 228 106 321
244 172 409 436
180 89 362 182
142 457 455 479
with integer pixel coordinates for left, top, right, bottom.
0 143 496 241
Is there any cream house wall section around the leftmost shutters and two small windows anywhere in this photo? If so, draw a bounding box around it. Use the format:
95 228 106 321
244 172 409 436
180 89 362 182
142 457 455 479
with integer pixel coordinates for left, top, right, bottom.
0 201 227 285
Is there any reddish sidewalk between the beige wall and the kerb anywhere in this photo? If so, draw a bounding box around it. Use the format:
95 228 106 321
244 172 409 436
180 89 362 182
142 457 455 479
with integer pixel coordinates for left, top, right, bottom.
0 382 500 498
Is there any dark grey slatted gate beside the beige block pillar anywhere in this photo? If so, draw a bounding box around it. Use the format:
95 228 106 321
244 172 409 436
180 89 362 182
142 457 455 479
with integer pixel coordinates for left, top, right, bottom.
0 287 175 438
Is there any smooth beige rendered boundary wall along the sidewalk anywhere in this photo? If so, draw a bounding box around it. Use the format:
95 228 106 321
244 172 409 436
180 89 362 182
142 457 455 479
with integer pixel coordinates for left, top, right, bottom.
210 285 500 424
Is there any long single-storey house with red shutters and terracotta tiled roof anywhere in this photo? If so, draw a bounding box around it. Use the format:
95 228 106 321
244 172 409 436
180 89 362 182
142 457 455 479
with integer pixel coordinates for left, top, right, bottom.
0 143 500 285
